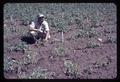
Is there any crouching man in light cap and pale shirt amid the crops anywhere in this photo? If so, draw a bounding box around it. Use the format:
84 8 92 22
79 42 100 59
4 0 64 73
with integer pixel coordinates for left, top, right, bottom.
29 14 50 41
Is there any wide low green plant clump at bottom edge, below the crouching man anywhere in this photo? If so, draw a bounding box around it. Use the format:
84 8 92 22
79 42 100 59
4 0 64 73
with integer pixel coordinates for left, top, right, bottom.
17 67 56 79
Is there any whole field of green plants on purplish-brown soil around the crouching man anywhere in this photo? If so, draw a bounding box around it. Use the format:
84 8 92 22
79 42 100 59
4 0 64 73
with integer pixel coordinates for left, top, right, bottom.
3 3 117 79
